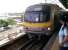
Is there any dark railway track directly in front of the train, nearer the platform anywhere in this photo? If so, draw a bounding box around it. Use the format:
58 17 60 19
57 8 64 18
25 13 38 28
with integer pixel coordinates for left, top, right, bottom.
20 37 49 50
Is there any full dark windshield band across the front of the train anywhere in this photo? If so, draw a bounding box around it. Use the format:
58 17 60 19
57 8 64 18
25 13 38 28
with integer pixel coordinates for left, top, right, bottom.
24 9 51 22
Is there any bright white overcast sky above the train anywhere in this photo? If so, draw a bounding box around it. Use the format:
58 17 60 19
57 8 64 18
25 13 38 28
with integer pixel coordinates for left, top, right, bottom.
0 0 66 15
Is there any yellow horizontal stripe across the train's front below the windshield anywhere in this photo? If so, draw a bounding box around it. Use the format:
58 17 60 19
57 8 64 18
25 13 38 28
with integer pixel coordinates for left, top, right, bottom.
23 22 51 27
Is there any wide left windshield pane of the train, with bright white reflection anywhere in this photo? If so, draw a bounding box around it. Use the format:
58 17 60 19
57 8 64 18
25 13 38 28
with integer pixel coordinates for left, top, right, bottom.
24 12 39 22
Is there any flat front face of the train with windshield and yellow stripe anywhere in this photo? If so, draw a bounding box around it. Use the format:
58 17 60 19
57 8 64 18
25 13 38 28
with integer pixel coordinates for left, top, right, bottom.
23 5 52 35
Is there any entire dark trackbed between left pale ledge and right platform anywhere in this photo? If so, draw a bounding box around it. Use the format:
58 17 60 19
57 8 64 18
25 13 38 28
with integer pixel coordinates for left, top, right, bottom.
0 35 53 50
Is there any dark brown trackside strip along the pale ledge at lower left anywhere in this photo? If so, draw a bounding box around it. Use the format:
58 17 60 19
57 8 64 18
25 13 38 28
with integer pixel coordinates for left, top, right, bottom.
0 35 29 50
